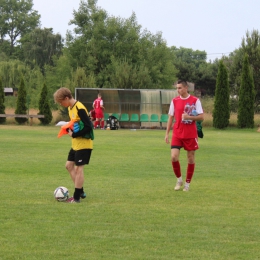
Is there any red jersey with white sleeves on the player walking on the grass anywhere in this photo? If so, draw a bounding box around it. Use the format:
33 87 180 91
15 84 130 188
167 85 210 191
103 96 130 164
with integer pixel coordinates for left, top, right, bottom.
169 95 203 139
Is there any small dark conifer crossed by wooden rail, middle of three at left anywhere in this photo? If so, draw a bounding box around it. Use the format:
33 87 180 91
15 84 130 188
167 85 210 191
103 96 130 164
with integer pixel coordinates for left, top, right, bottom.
14 78 28 124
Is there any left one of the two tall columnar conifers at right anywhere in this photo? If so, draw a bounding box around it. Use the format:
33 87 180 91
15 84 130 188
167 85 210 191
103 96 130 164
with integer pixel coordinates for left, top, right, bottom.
213 61 230 129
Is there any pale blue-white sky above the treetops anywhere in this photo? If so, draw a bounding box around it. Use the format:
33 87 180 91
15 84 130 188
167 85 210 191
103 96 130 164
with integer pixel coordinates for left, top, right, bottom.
33 0 260 60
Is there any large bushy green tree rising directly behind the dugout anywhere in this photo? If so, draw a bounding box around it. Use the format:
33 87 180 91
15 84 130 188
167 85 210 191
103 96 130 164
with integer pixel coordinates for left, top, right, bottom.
67 0 176 88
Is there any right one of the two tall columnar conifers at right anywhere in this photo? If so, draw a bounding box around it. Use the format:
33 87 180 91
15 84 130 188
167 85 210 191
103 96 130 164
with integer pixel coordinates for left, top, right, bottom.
237 54 255 128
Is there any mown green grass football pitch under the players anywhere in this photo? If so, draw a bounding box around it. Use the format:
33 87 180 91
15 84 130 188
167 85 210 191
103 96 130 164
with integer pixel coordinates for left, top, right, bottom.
0 125 260 260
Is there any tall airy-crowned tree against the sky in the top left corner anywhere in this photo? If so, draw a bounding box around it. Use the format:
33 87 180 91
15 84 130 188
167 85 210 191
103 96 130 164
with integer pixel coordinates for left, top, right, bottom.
0 0 40 56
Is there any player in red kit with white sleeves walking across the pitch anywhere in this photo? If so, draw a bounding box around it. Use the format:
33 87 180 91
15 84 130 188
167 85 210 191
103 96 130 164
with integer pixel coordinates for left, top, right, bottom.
165 80 204 191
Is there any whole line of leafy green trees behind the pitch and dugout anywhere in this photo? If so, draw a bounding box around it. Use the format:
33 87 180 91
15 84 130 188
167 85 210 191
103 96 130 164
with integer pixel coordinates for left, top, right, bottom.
0 0 260 126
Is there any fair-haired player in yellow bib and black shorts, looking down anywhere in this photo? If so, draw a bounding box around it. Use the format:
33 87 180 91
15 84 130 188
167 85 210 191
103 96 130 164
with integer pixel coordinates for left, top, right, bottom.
53 87 93 203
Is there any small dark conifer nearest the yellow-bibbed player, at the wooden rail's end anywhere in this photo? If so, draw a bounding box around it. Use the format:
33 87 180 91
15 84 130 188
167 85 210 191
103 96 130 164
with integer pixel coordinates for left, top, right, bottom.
38 83 52 125
